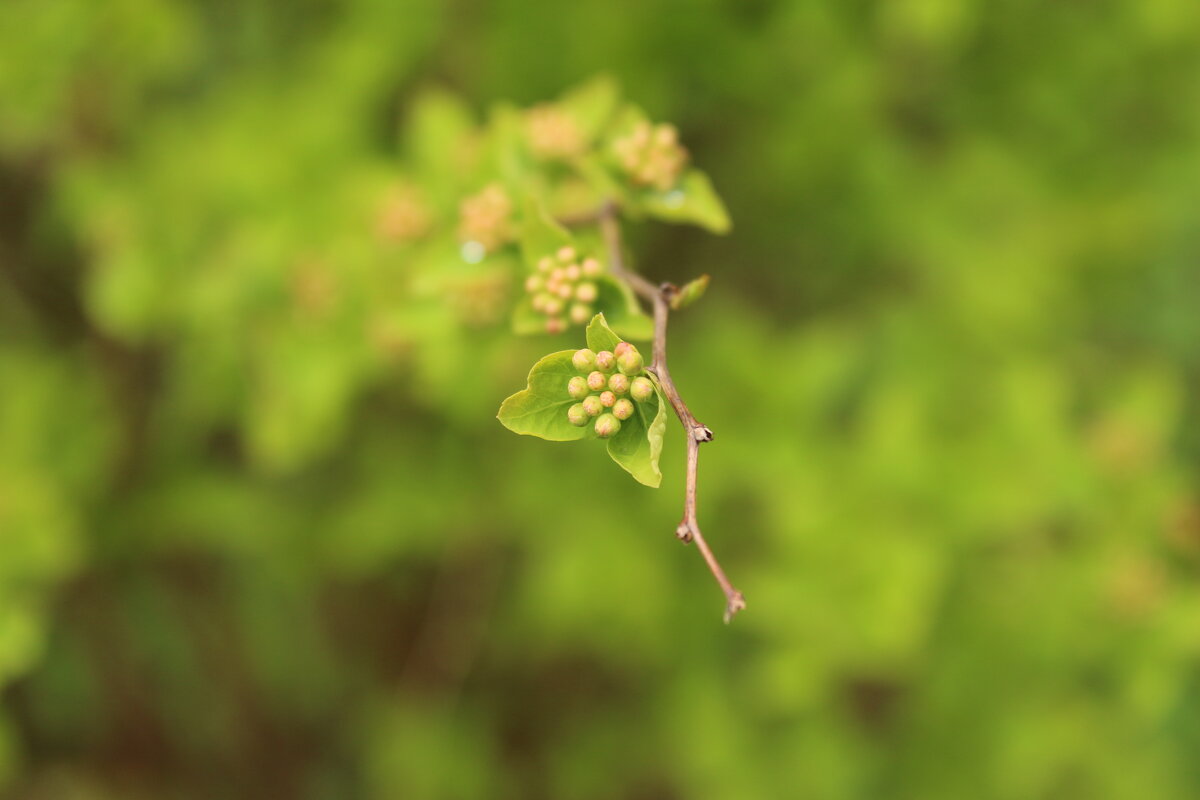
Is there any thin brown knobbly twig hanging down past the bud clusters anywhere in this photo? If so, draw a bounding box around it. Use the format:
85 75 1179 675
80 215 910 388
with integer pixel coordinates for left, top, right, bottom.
598 203 746 622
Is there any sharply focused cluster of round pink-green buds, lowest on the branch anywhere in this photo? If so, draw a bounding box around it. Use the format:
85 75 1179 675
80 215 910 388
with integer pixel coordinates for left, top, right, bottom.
566 342 654 439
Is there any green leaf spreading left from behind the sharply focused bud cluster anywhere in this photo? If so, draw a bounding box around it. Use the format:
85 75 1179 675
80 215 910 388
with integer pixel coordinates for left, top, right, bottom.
496 350 595 441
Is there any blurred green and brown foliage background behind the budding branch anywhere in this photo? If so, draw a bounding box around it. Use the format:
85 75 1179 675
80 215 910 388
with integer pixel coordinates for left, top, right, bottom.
0 0 1200 800
